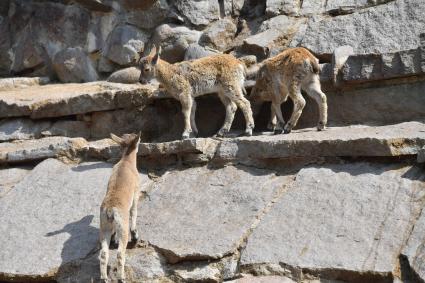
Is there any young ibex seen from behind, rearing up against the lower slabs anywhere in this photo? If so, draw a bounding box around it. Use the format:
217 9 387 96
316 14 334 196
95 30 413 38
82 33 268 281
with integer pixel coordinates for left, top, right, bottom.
99 133 140 282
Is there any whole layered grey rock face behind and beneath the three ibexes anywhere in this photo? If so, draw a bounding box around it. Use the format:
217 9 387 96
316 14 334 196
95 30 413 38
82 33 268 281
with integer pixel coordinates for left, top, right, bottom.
0 0 425 283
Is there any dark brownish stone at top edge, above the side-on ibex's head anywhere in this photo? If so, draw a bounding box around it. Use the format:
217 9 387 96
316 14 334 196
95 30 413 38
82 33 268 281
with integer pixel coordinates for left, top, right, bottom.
125 0 170 29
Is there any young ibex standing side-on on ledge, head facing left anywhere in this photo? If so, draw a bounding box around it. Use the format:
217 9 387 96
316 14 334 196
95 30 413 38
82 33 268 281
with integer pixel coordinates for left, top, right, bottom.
139 46 254 139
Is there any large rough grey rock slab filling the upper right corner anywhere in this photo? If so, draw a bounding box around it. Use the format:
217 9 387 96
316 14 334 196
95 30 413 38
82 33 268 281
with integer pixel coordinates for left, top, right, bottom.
290 0 425 58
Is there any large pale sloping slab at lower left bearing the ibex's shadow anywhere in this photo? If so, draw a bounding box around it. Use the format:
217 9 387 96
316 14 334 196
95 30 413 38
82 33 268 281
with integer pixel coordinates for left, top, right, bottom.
0 159 152 278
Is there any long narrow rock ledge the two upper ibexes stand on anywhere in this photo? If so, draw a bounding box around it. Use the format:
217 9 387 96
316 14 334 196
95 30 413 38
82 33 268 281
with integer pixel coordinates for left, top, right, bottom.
0 122 425 163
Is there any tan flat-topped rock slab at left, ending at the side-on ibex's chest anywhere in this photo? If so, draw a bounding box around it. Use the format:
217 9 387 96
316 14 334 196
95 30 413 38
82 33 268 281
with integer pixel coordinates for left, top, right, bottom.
0 82 157 119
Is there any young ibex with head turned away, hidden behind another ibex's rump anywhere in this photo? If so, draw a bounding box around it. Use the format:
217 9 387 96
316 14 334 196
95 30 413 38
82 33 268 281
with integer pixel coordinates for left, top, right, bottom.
250 47 328 133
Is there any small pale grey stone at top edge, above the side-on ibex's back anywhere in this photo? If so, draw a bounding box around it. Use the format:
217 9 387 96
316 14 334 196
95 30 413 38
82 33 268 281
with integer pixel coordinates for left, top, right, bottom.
174 0 220 26
